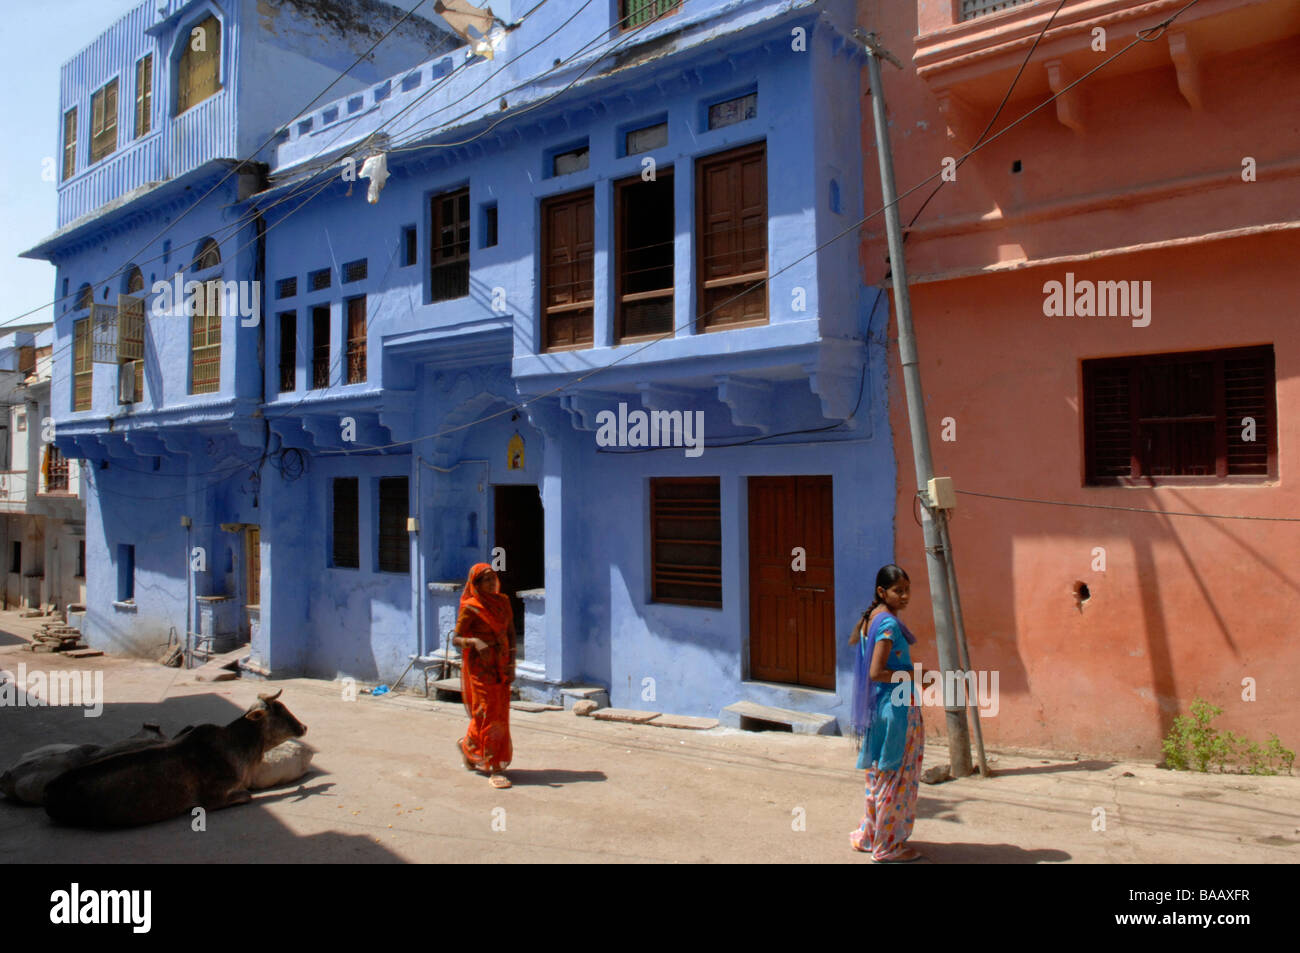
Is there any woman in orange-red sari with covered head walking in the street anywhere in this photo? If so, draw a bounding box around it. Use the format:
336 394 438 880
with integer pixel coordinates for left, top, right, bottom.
451 563 515 788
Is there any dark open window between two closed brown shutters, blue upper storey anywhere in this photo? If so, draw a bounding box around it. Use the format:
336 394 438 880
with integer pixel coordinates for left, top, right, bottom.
615 170 676 339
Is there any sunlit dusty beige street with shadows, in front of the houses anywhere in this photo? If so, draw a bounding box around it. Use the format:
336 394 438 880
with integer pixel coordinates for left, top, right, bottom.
0 614 1300 863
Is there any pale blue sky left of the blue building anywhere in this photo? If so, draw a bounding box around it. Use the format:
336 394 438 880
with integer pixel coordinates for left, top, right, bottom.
0 0 140 326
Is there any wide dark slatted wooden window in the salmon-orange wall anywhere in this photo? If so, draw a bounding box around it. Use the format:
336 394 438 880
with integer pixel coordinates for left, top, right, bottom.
1083 346 1278 486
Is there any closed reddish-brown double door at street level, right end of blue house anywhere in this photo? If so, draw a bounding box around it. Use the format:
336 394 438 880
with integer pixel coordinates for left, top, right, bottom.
749 476 835 688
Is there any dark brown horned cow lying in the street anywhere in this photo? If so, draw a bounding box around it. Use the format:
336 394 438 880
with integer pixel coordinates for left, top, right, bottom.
46 692 307 827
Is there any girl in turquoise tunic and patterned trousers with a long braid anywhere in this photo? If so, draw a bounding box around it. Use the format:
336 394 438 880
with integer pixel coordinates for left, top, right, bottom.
849 563 926 863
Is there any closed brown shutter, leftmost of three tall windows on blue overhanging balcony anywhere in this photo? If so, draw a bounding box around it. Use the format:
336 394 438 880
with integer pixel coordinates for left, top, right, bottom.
542 189 595 350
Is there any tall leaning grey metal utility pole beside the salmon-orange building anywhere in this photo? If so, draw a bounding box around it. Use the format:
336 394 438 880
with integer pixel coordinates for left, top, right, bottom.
857 33 971 777
